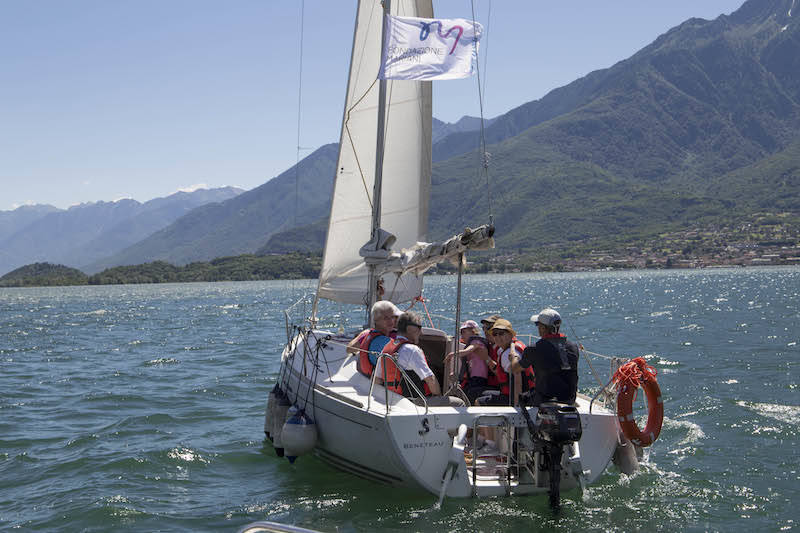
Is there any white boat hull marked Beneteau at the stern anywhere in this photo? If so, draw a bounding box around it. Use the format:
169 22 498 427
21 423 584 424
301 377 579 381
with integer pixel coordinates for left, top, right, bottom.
268 331 618 497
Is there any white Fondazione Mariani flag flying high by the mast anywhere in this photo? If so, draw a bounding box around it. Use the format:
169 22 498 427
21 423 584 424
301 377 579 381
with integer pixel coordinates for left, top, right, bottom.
379 16 483 80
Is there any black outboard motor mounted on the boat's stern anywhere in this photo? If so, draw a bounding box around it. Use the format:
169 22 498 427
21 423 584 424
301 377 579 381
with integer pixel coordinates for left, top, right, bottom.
519 392 583 512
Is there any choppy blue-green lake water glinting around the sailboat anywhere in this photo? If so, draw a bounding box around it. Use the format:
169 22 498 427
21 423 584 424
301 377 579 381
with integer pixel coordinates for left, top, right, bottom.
0 268 800 532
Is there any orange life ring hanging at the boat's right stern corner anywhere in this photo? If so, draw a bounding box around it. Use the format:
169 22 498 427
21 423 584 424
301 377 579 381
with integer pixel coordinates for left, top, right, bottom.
614 357 664 448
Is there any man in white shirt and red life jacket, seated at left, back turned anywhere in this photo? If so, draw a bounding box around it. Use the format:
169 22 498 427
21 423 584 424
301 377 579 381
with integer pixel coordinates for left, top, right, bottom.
375 311 464 407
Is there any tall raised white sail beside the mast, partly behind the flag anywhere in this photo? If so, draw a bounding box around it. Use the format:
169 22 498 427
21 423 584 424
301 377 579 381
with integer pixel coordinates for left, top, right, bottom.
317 0 433 304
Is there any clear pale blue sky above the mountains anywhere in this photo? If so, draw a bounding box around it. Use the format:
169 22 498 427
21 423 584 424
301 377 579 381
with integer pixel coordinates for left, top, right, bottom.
0 0 742 210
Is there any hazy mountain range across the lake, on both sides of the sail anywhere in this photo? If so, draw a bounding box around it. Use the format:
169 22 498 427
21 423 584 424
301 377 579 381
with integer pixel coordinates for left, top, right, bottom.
0 0 800 272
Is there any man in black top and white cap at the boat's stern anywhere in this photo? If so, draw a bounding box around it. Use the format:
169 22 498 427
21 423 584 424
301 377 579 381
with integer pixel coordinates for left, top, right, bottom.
515 308 580 405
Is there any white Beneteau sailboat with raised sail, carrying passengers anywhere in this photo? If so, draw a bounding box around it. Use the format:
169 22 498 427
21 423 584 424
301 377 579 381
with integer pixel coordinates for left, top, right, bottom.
265 0 660 501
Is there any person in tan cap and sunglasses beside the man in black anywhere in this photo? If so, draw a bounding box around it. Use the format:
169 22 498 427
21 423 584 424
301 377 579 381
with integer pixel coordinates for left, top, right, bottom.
478 318 533 405
